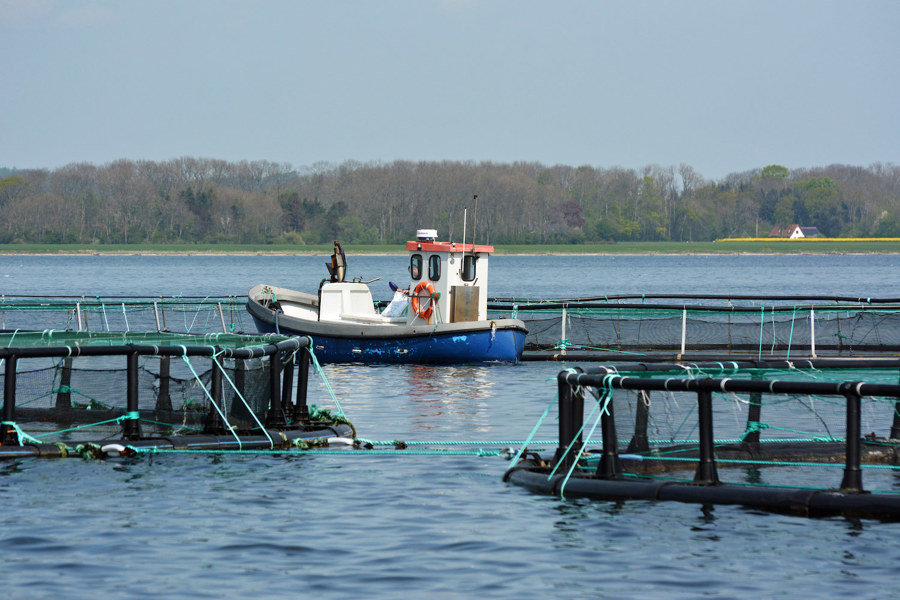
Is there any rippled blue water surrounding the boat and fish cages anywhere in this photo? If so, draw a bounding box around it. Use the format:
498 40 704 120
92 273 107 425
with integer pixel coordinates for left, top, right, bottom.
0 251 900 598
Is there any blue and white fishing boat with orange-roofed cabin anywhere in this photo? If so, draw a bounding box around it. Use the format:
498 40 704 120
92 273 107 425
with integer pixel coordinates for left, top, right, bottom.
247 229 528 364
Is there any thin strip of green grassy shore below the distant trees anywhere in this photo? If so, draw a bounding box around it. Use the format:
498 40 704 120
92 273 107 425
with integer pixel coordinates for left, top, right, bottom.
0 238 900 255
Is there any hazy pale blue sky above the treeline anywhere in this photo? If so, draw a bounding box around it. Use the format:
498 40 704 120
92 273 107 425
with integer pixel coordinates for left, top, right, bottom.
0 0 900 180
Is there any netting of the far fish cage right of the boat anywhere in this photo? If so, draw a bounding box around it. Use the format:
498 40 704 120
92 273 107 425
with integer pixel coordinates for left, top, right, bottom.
493 304 900 356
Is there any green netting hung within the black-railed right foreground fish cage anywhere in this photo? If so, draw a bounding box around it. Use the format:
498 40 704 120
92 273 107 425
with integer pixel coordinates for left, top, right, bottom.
536 362 900 489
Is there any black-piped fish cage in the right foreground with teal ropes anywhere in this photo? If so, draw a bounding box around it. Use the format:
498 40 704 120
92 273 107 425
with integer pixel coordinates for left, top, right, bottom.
504 358 900 521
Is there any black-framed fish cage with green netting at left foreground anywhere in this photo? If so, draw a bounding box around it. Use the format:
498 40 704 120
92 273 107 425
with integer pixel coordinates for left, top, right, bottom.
0 331 355 459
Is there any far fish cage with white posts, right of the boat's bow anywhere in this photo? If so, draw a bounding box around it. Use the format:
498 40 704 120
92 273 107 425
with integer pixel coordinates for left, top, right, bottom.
488 294 900 361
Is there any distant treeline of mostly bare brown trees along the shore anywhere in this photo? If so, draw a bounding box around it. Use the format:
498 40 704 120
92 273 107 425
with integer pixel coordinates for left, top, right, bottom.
0 158 900 244
